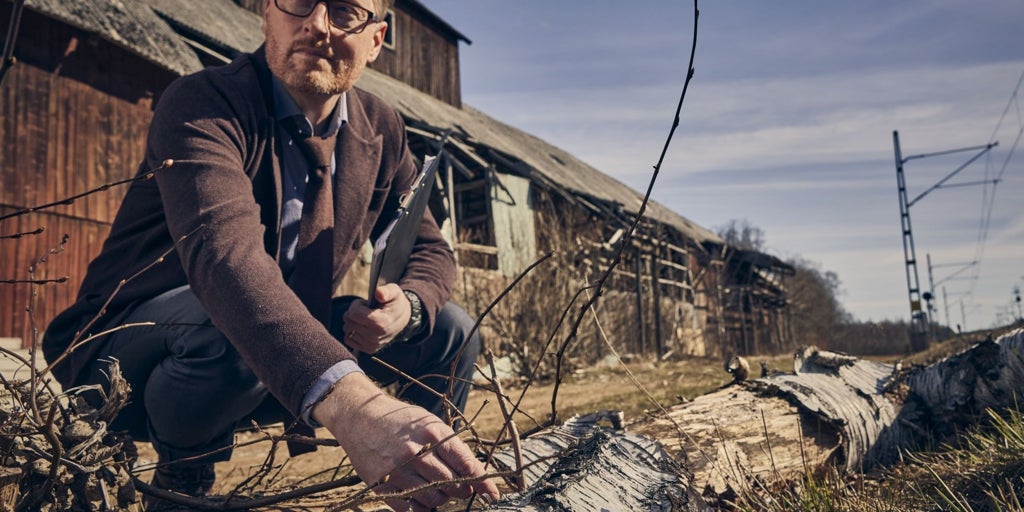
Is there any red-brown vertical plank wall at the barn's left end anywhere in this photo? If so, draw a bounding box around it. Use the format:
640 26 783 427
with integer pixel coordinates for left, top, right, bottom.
0 16 161 340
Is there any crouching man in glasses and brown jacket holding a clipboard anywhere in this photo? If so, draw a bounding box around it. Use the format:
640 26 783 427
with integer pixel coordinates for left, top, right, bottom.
43 0 498 510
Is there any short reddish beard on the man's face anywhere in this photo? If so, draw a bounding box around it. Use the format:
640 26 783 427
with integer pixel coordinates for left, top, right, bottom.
266 35 366 96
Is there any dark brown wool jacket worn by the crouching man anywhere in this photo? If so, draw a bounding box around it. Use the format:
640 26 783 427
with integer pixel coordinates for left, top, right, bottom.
43 48 455 413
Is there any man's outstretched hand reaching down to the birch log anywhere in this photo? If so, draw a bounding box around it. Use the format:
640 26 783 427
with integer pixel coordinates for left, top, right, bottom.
312 373 499 510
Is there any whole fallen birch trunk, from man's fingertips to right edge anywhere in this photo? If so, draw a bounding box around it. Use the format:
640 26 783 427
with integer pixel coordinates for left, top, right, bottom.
493 330 1024 510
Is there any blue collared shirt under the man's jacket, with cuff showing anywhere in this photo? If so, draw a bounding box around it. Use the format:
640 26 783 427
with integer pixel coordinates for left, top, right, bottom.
271 77 362 428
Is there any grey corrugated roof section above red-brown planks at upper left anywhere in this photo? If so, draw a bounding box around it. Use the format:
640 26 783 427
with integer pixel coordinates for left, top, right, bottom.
25 0 203 75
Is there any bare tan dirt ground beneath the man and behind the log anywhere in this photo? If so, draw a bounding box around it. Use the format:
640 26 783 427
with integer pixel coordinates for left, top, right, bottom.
130 356 770 510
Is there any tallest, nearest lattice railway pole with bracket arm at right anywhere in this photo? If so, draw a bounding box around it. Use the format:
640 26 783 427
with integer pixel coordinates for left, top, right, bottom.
893 130 998 352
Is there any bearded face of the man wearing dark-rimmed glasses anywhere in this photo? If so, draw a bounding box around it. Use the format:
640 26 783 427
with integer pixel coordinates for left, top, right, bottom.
263 0 387 96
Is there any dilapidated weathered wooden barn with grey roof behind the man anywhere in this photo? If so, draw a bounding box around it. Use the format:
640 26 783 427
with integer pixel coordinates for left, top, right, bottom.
0 0 792 355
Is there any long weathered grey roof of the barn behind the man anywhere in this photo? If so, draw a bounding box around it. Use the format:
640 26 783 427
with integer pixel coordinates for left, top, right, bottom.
26 0 722 243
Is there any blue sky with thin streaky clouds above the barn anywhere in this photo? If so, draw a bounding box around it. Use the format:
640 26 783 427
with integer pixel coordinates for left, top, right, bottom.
421 0 1024 330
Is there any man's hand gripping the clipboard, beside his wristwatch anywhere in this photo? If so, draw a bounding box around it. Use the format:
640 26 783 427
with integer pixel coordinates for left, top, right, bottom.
345 283 412 354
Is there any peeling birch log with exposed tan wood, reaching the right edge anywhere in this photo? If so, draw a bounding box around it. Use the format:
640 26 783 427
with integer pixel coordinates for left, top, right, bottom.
629 330 1024 497
